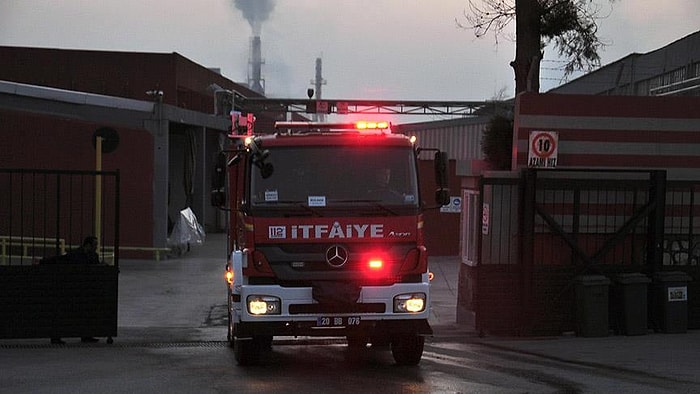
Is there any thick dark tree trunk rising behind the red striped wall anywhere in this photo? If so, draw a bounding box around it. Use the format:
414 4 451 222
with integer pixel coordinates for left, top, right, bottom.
510 0 542 95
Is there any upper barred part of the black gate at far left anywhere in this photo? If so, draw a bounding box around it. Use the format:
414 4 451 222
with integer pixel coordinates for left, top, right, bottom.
0 169 119 265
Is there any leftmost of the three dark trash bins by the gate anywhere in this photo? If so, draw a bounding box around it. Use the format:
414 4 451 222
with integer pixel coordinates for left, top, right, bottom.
574 275 610 337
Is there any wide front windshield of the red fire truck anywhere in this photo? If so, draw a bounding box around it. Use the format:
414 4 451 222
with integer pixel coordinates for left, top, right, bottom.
250 145 419 209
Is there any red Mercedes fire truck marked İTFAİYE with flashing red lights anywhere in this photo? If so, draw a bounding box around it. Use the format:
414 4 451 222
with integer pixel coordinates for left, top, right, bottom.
212 118 449 365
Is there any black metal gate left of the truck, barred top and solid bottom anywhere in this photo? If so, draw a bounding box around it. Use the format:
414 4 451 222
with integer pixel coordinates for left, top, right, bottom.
0 169 119 339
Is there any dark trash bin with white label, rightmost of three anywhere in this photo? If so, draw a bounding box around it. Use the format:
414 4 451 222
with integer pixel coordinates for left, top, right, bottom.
653 271 692 334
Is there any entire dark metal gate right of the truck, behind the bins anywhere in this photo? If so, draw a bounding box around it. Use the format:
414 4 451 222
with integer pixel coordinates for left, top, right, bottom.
460 169 700 335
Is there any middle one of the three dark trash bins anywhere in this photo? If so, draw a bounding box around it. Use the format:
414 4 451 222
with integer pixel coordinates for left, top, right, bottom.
610 272 651 335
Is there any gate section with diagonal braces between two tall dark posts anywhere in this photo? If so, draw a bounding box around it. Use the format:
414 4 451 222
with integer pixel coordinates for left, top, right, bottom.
520 169 666 333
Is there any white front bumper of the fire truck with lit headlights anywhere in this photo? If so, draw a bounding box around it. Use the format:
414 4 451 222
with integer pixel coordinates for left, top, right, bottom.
230 283 432 337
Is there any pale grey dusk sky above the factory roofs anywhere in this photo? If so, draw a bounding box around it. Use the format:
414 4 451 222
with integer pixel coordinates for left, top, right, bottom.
0 0 700 106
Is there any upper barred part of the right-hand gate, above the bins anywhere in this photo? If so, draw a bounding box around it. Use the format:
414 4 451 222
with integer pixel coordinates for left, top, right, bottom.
474 171 700 268
